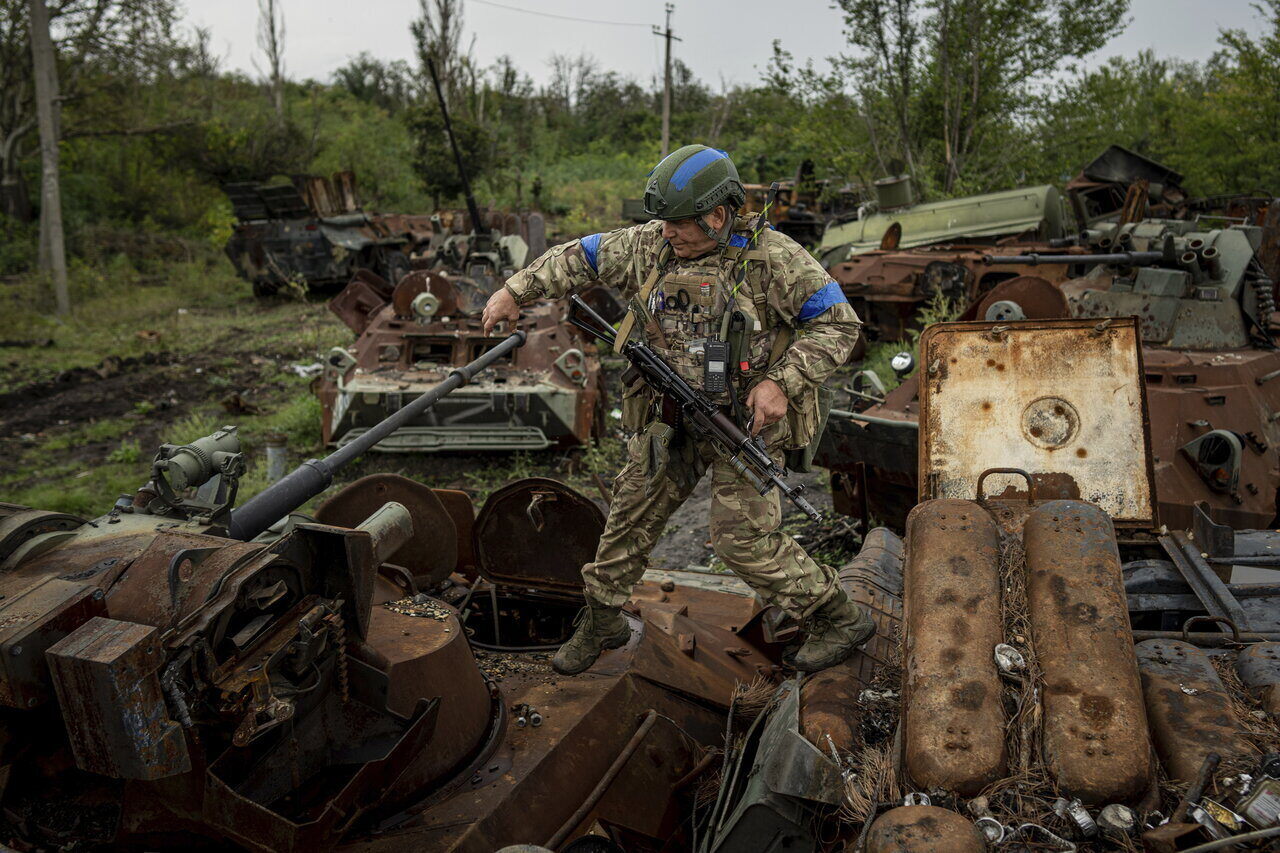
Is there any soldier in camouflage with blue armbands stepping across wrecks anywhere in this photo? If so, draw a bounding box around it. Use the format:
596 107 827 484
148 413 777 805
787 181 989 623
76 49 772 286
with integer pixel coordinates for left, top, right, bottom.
484 145 874 675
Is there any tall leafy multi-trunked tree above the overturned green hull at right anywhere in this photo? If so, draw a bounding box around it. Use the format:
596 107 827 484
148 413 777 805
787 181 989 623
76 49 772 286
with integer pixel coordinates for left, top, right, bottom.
837 0 1129 193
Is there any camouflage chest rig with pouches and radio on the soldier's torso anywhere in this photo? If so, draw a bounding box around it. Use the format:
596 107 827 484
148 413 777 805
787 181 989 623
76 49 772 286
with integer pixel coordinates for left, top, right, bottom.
617 219 790 405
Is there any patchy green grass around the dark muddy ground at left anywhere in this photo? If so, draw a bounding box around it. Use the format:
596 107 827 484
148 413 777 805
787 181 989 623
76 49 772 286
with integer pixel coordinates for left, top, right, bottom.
0 245 351 516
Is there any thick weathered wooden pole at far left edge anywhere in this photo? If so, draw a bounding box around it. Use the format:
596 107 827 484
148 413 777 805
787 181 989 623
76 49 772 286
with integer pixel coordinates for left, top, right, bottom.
29 0 72 316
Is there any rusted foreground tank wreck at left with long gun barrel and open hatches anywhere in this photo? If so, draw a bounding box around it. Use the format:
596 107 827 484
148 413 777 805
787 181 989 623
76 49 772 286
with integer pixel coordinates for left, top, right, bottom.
0 333 774 853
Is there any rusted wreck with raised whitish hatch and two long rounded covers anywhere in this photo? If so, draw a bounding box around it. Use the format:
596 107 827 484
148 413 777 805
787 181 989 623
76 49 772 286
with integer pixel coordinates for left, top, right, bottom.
783 318 1280 853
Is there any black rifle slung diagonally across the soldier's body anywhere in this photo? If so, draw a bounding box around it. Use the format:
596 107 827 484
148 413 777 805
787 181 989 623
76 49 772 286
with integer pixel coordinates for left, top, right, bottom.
568 290 822 521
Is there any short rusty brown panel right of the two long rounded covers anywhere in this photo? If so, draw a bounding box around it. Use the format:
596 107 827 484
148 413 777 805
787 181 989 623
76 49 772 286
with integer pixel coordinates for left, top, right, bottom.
1135 640 1251 783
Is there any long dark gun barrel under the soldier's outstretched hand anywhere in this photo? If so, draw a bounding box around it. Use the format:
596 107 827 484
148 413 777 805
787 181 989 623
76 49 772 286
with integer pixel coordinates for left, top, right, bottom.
228 326 525 542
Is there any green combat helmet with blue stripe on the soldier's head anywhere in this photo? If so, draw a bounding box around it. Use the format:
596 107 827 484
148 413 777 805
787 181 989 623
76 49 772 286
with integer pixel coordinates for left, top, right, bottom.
644 145 746 222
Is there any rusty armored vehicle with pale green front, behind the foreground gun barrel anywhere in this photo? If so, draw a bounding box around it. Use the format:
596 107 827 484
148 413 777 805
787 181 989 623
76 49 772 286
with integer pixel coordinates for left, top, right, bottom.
317 59 606 452
